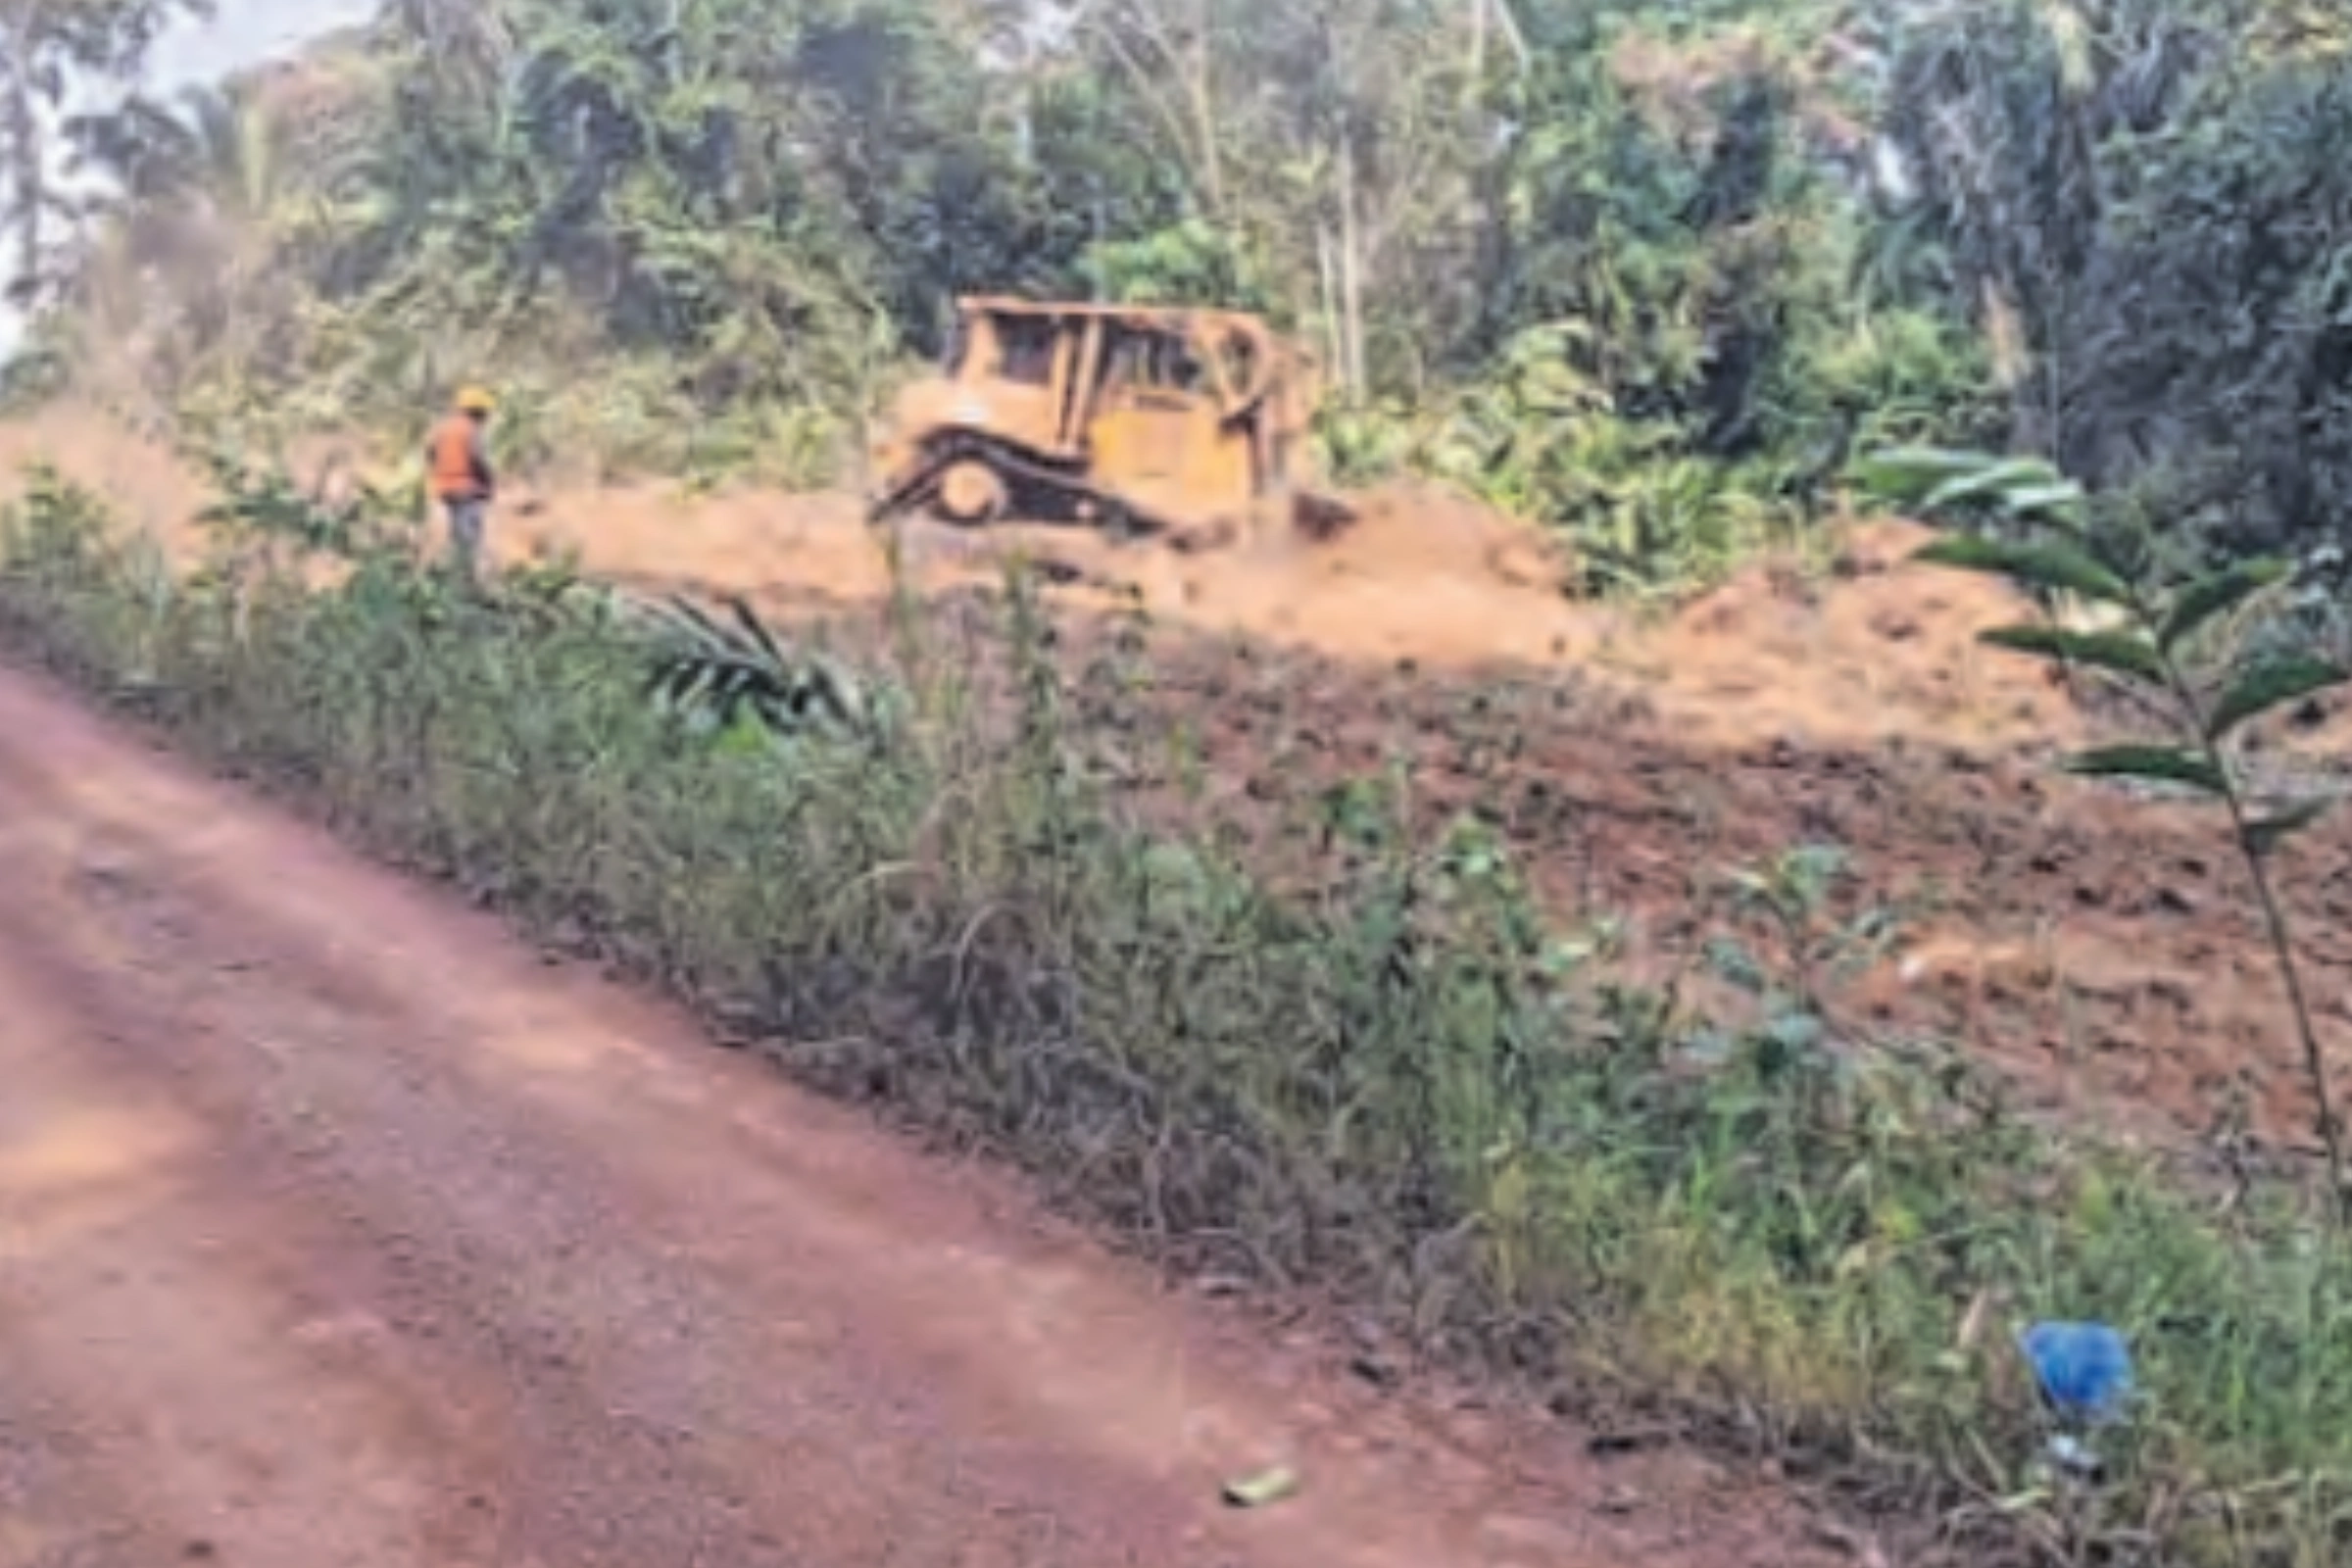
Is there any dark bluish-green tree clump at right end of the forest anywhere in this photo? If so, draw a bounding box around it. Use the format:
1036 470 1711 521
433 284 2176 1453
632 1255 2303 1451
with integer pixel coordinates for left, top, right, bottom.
1891 0 2352 575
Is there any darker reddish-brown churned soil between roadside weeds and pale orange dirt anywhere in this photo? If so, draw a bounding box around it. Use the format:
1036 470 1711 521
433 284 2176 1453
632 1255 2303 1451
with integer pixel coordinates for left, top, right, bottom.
1105 634 2352 1145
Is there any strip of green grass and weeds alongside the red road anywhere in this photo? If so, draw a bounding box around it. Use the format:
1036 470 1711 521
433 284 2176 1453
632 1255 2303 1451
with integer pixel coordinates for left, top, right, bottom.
0 461 2352 1568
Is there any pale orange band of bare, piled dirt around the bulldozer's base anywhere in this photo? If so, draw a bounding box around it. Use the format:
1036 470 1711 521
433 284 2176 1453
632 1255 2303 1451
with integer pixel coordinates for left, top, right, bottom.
0 409 2068 745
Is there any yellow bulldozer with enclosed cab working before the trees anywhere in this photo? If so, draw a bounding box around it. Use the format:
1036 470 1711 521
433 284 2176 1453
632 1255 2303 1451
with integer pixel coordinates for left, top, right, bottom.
868 299 1346 543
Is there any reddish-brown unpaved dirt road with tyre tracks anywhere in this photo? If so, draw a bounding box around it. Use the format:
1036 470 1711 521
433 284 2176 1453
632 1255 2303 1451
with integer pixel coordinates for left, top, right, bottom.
0 677 1813 1568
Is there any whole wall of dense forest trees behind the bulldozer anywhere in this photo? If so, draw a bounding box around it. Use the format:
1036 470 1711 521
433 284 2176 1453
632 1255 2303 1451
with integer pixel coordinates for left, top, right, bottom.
17 0 2352 581
